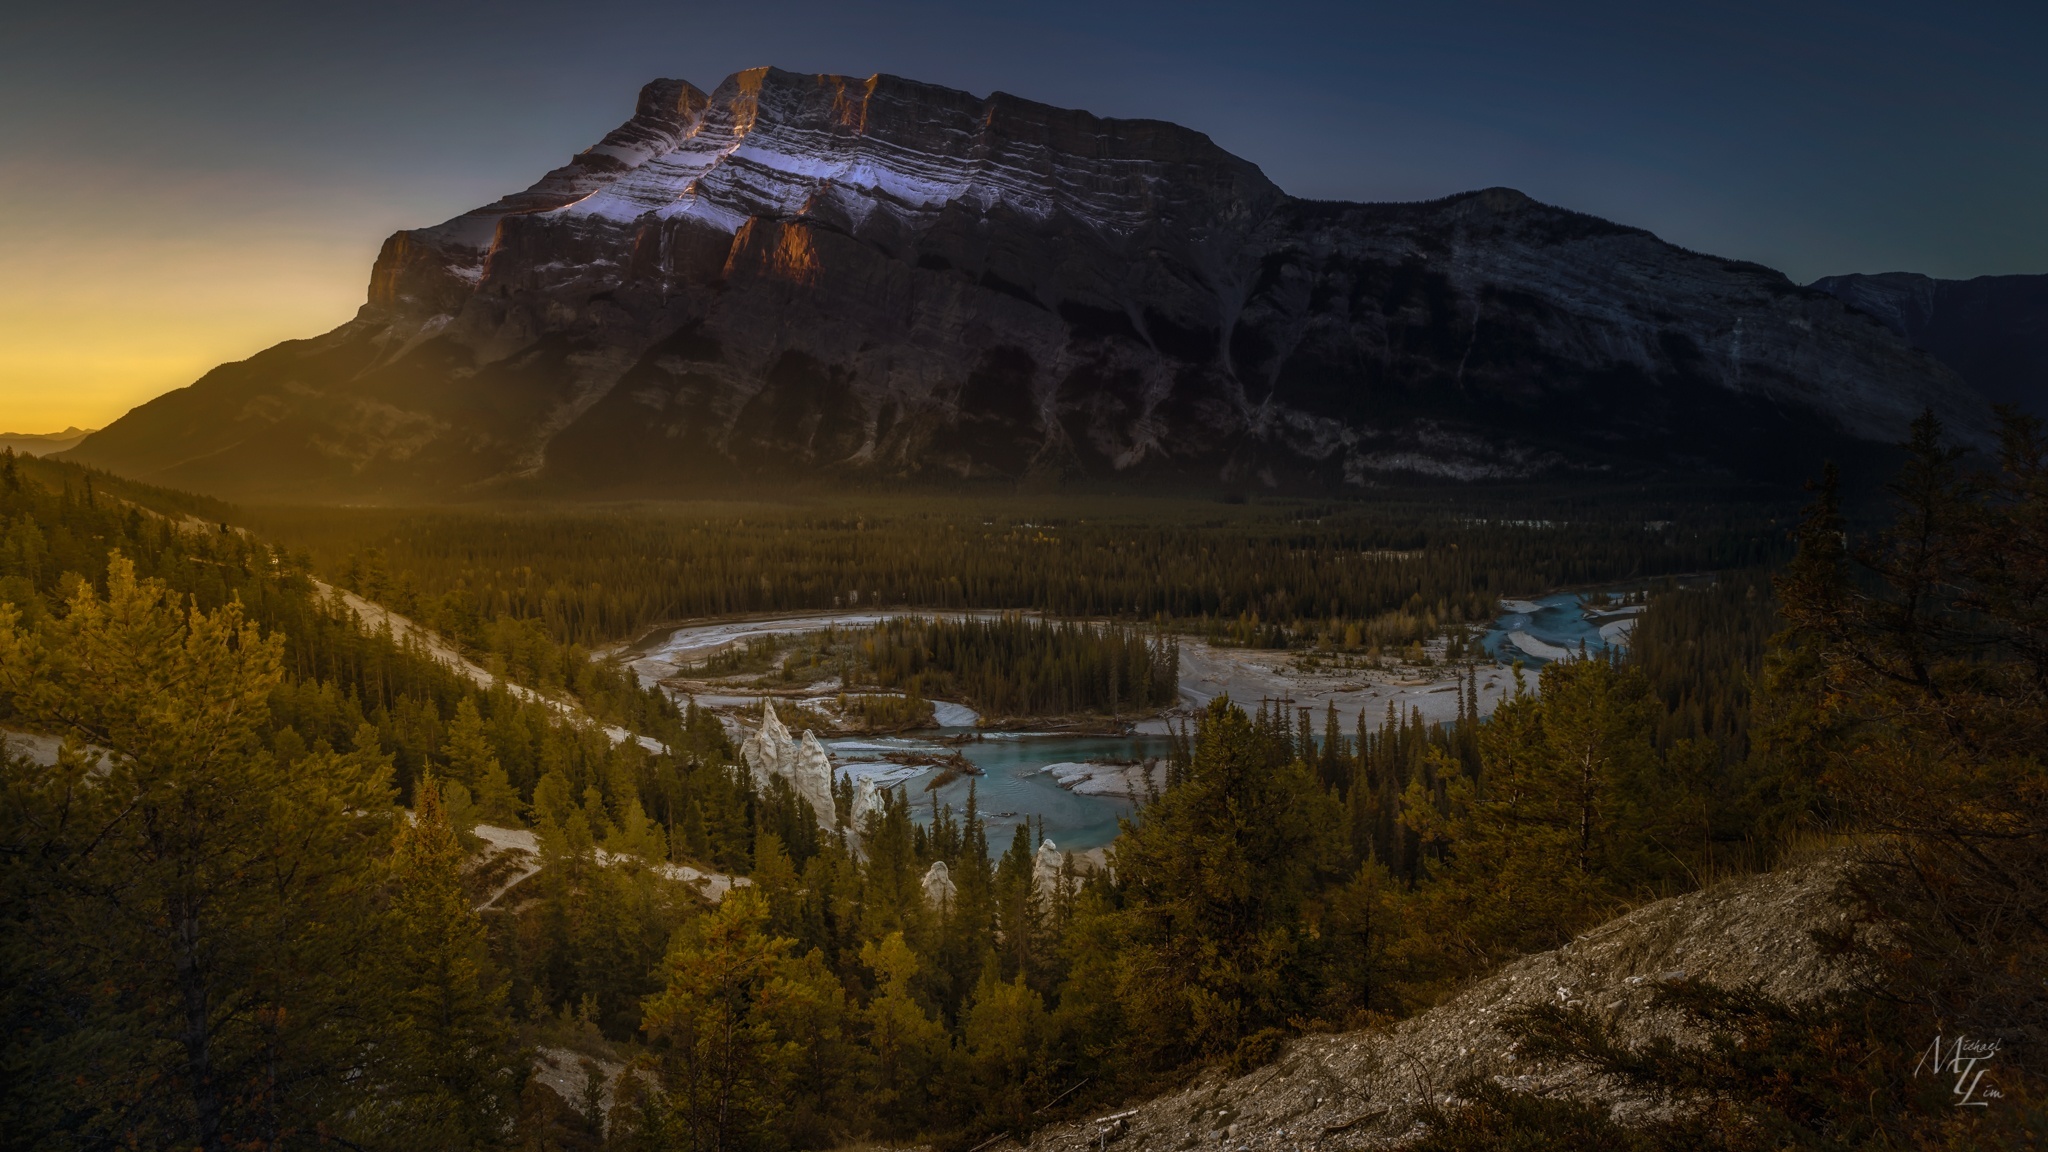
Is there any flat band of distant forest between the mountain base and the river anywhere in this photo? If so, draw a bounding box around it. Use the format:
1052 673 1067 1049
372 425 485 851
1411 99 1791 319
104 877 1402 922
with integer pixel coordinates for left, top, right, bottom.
244 496 1796 660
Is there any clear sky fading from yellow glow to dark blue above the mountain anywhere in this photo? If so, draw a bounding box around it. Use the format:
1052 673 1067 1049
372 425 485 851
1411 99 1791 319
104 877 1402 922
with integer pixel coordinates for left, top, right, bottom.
0 0 2048 433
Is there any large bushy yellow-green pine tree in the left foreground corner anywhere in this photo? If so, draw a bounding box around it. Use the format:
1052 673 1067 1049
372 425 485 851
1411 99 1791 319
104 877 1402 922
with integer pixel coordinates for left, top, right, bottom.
0 553 393 1152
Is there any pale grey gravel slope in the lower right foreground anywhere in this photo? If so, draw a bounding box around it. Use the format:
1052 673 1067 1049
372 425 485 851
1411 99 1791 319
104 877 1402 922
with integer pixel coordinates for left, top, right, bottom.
1008 857 1875 1152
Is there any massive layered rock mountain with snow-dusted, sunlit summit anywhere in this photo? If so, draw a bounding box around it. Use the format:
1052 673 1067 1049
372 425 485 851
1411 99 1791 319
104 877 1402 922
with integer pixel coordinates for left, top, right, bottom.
72 68 1989 498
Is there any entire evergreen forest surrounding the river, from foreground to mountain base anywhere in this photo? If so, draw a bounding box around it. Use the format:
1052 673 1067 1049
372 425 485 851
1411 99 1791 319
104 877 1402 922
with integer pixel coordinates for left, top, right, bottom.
0 430 2048 1152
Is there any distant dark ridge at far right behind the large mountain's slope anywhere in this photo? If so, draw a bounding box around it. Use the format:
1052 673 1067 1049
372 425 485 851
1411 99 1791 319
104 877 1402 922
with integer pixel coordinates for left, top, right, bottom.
1812 273 2048 418
